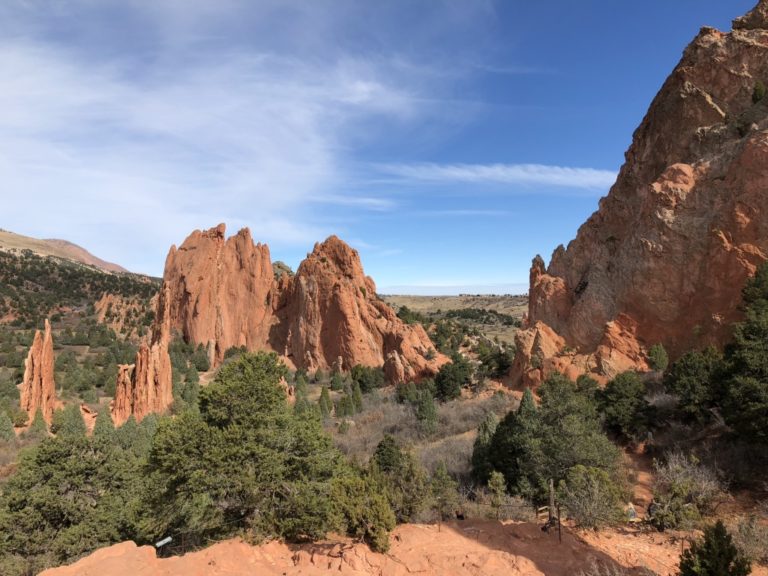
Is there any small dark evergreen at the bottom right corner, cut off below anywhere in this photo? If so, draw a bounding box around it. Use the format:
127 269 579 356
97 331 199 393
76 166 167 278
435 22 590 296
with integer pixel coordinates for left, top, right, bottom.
679 520 751 576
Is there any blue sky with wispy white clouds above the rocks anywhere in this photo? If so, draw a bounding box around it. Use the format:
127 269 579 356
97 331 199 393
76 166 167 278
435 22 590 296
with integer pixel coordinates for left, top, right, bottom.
0 0 755 293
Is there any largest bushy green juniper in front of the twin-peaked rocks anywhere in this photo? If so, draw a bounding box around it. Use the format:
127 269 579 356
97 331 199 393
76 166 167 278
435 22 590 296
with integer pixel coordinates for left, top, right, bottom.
142 353 396 545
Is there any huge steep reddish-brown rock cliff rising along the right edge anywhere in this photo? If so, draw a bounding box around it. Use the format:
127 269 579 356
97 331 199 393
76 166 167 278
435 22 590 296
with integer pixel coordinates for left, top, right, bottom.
513 0 768 384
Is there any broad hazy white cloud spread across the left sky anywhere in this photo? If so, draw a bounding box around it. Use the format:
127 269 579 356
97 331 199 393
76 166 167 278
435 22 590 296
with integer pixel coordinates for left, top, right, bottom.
0 41 418 273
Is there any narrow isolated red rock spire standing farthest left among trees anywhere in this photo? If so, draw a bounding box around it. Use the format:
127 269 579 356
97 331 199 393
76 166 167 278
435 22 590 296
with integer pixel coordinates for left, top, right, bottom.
20 319 56 425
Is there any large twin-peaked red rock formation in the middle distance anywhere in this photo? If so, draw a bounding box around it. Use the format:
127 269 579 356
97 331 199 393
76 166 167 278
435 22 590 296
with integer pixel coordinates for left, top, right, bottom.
155 224 447 382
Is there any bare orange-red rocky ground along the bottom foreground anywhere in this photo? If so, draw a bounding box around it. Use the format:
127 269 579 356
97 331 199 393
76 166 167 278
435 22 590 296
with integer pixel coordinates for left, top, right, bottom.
41 520 768 576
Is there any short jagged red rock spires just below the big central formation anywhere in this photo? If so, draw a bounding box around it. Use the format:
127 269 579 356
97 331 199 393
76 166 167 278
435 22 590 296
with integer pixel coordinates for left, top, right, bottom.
110 341 173 426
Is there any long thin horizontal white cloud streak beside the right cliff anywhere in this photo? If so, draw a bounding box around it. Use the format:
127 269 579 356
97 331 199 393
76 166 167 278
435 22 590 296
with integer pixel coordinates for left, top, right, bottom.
377 163 616 190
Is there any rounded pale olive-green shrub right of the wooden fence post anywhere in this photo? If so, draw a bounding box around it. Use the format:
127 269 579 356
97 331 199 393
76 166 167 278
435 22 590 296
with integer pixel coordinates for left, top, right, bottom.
559 465 622 530
